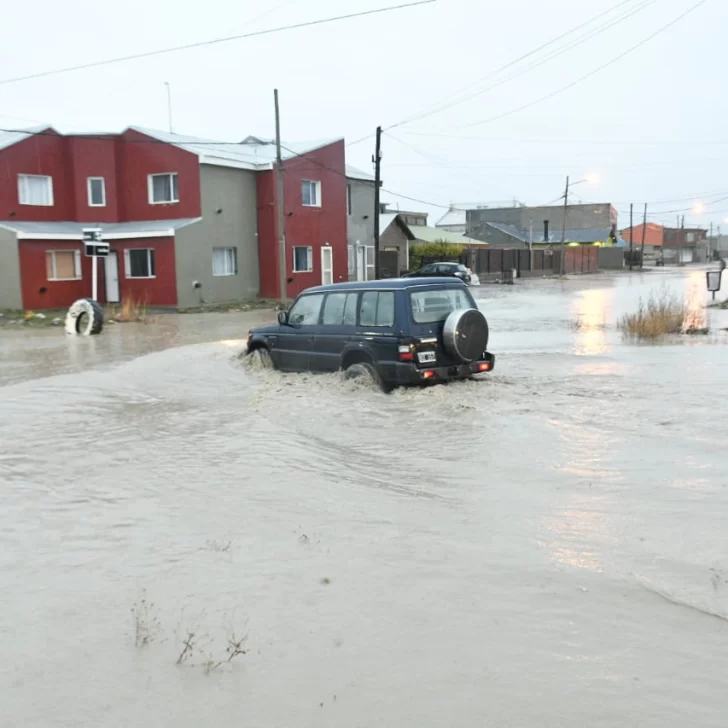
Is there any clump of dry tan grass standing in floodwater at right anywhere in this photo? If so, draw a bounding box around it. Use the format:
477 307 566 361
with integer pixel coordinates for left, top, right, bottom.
617 289 705 340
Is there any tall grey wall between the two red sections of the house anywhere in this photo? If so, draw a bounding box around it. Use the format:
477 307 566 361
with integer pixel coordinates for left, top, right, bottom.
175 164 260 308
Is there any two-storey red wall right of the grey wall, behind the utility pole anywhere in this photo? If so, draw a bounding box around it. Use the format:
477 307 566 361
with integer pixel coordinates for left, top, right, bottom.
258 141 348 298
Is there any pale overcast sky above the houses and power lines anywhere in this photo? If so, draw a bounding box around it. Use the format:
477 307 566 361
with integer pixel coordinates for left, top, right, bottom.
0 0 728 232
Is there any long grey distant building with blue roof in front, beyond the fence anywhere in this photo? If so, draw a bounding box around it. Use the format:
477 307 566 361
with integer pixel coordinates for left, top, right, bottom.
466 203 622 248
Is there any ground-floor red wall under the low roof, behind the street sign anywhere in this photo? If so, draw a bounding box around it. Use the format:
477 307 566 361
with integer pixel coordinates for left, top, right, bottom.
18 238 177 310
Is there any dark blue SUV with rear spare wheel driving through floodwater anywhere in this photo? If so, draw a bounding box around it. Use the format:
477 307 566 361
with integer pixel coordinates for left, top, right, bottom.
247 278 495 391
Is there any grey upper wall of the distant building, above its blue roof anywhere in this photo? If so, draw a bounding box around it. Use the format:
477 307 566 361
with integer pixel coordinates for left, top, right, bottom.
466 203 611 238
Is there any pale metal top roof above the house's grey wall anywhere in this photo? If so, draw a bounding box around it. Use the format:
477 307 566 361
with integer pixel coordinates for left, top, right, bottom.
128 126 342 170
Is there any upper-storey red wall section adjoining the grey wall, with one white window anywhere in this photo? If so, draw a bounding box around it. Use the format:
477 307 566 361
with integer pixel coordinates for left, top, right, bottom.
116 131 201 221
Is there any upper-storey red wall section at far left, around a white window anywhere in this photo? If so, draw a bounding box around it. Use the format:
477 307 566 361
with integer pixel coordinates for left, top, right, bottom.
0 130 74 222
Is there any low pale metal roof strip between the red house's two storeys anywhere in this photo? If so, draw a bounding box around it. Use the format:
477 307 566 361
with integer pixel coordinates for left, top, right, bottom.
0 217 202 240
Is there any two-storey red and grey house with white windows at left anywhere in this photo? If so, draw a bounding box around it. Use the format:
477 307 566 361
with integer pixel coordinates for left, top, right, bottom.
0 127 347 309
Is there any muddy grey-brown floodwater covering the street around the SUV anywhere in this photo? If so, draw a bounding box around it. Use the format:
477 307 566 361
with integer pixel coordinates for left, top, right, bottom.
0 269 728 728
